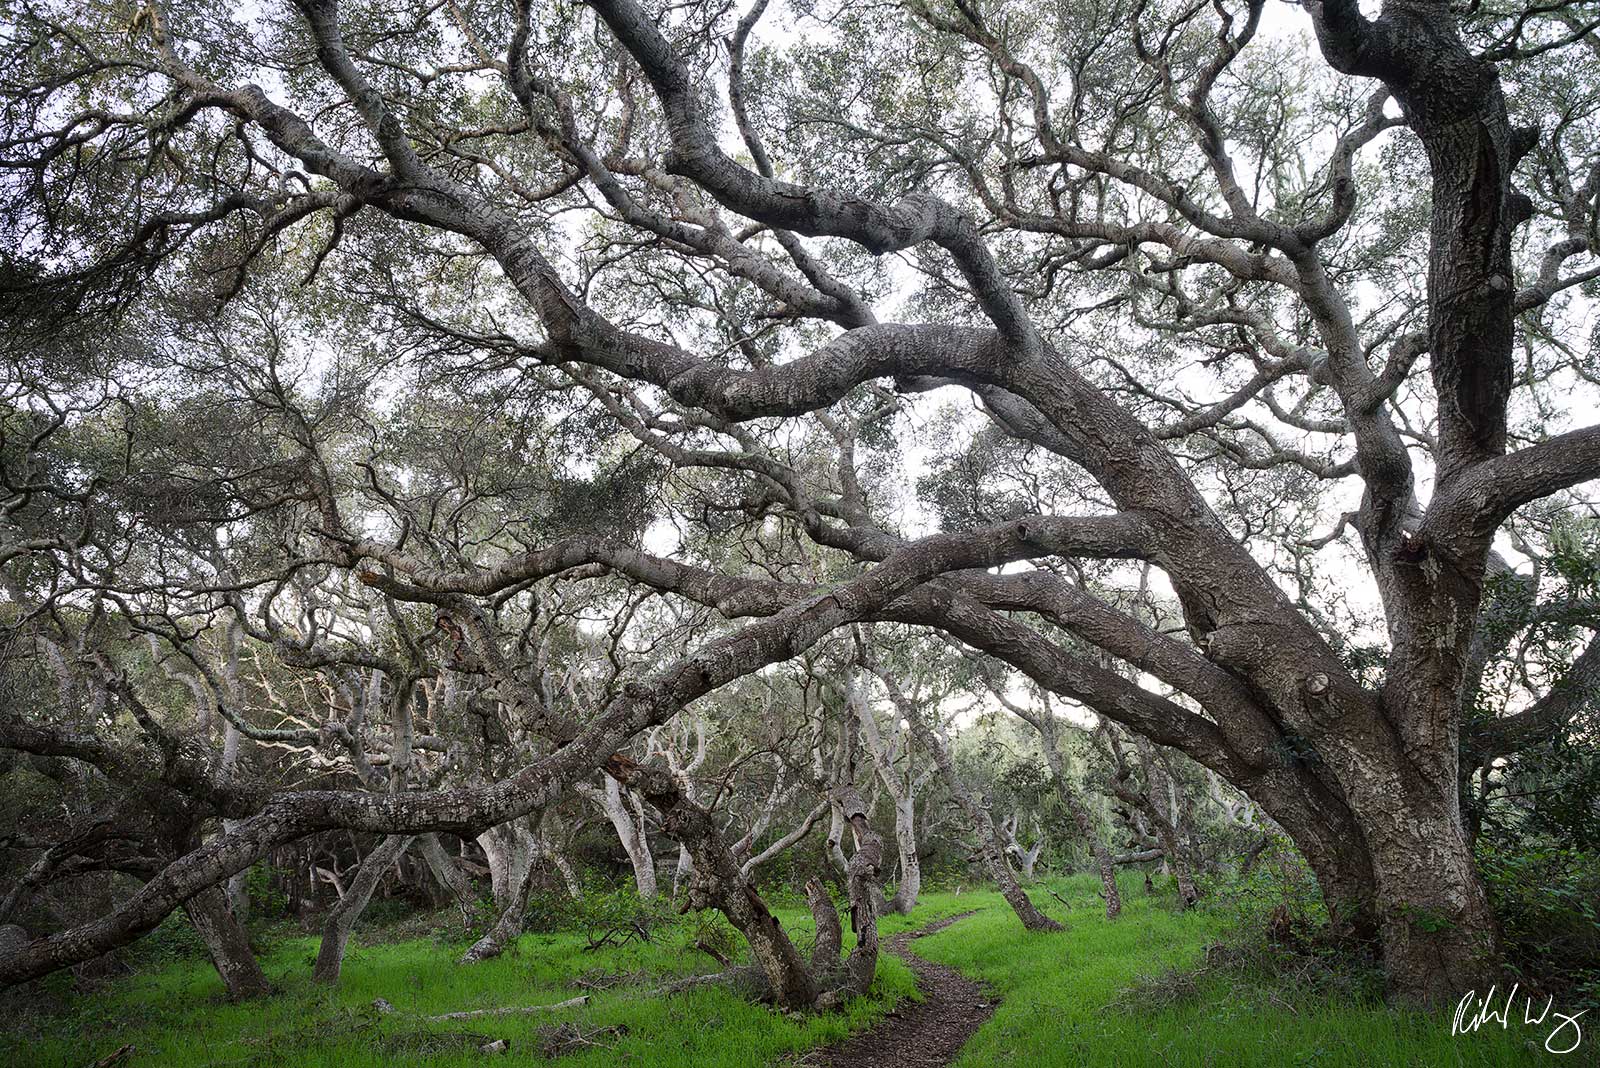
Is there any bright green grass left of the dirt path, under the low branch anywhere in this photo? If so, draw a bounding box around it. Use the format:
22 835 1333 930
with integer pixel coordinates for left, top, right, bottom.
0 895 973 1068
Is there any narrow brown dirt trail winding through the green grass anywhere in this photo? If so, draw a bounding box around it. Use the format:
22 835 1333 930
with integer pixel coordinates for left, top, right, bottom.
803 913 995 1068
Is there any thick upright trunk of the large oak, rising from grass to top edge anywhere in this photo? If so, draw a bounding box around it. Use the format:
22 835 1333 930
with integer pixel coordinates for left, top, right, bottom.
1307 0 1516 1002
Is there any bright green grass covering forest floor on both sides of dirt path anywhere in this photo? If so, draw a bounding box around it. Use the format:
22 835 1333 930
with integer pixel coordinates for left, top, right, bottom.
0 878 1574 1068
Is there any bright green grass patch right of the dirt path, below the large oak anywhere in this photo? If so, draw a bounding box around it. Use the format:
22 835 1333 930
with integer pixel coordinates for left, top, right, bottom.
917 876 1568 1068
